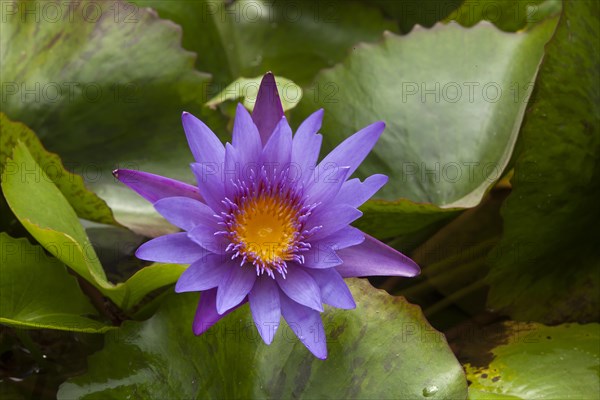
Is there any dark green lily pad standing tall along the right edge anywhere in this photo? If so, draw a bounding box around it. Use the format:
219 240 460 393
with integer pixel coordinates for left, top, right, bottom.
488 0 600 323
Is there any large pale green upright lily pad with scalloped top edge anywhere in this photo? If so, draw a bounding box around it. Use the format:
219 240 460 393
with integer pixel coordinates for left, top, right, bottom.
295 20 556 208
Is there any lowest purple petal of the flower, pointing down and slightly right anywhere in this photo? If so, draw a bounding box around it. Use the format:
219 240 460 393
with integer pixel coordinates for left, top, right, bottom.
280 293 327 360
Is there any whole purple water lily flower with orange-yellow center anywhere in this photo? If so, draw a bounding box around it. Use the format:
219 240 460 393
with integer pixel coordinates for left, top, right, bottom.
114 73 419 359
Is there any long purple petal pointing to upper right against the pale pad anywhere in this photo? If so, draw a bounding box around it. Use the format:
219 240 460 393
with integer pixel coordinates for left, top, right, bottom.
317 121 385 176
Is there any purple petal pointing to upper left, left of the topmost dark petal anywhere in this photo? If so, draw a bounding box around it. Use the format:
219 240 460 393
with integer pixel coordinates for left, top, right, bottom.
181 112 225 165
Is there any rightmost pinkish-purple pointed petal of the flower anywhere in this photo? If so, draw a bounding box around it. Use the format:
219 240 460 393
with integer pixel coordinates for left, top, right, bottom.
335 234 421 278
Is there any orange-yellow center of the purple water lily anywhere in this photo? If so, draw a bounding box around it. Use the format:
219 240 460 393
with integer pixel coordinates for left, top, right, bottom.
233 195 298 267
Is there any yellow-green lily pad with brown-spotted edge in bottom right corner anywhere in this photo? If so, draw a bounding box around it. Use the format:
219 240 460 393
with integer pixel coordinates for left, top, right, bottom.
465 322 600 399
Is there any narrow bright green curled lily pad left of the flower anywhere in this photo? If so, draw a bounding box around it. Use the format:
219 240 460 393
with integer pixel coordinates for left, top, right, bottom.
2 143 185 310
